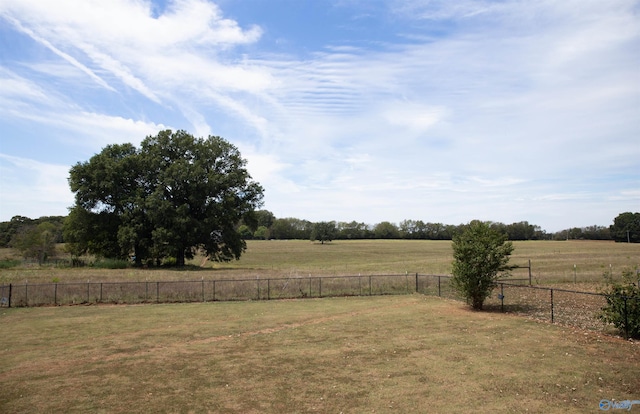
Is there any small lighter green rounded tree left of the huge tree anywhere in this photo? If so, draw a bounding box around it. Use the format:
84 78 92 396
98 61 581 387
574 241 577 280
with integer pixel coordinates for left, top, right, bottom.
11 222 56 264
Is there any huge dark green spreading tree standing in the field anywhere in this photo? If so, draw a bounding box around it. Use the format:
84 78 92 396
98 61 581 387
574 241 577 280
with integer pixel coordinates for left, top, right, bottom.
65 130 263 266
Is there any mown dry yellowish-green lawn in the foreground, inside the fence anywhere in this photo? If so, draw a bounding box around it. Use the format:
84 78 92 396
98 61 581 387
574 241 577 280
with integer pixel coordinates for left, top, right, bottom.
0 295 640 413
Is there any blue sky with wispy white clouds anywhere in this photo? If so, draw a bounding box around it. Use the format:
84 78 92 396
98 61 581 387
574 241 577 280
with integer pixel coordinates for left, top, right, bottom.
0 0 640 232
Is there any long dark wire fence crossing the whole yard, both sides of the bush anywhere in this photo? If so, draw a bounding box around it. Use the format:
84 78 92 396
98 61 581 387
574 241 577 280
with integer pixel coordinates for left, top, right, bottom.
0 274 640 334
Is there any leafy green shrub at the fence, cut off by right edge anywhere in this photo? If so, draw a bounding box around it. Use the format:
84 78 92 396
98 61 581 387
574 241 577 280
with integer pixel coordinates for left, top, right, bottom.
598 269 640 338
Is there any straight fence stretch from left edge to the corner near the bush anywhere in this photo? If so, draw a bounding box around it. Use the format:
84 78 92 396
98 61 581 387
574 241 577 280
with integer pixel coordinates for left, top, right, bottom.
0 274 430 307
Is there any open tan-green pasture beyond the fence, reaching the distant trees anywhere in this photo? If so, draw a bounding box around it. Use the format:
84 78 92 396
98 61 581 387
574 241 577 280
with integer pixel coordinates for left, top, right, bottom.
0 240 640 285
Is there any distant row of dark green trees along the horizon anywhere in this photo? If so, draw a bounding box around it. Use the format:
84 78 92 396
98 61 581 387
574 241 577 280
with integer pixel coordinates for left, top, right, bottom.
0 210 640 256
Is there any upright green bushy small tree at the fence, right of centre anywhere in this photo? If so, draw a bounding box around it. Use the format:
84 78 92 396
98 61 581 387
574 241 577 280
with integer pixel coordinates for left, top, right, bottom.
451 221 513 309
